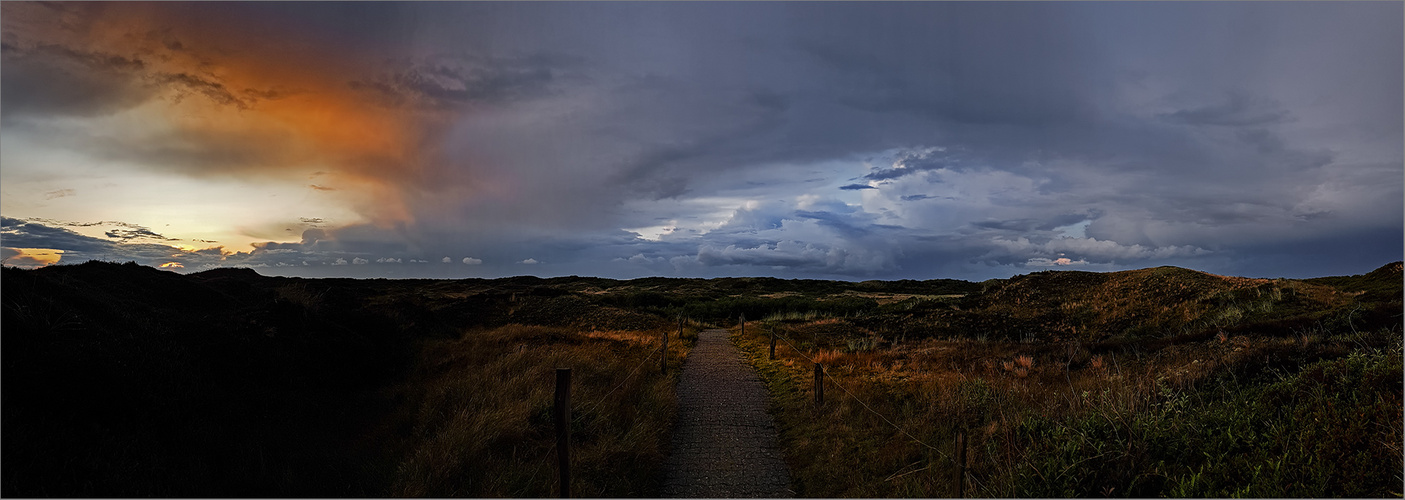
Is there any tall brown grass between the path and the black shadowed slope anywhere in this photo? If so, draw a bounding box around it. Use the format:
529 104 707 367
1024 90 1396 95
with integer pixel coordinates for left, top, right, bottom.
385 324 695 497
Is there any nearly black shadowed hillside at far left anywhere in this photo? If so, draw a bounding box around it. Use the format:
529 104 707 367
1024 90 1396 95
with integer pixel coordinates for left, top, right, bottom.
3 263 410 496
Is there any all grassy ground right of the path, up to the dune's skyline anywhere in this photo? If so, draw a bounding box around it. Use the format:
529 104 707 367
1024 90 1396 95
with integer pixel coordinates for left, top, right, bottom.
736 264 1405 497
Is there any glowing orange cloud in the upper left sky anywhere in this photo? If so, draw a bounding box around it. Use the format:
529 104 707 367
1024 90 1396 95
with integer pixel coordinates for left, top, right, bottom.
4 3 444 225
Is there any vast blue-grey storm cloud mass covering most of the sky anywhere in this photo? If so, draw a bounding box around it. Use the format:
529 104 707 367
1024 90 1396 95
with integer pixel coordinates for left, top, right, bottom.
4 3 1405 278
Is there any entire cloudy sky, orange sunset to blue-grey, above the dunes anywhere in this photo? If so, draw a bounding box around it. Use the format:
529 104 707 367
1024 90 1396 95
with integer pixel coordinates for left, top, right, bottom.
0 1 1405 281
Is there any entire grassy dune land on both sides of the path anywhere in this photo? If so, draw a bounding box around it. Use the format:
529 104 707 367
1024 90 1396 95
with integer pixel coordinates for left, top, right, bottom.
0 263 1405 497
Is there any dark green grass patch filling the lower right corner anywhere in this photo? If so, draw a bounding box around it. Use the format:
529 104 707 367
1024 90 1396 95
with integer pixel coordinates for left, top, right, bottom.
1002 336 1405 497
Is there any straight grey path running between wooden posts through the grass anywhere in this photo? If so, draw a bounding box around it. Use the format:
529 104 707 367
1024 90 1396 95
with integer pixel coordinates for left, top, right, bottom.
663 330 795 499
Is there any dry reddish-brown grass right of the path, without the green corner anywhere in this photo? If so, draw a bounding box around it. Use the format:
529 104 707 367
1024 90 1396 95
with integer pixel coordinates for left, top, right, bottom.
739 318 1399 497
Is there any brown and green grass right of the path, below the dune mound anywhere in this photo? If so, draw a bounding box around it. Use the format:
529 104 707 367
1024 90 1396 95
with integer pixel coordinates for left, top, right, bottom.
736 323 1405 497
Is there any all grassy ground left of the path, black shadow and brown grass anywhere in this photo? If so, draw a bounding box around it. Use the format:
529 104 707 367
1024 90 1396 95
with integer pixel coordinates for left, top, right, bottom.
0 263 697 497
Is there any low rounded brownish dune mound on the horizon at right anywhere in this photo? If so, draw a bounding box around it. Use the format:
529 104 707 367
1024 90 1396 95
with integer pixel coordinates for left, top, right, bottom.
882 267 1376 340
